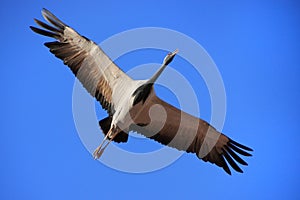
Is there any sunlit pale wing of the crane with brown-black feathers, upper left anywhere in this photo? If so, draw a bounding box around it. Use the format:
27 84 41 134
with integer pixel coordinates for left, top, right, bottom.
30 9 132 114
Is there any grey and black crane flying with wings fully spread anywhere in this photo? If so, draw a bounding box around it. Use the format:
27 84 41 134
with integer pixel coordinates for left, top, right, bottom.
30 9 252 174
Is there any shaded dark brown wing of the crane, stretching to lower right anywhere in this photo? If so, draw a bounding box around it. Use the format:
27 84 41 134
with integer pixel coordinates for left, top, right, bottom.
130 94 252 174
